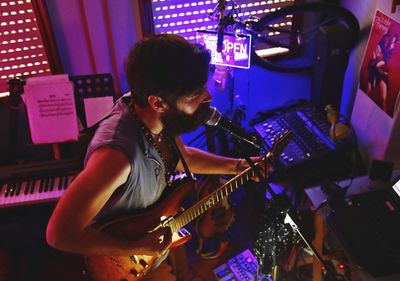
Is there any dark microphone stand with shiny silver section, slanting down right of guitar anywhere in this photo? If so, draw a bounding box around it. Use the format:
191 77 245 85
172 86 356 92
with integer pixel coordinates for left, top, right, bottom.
231 134 346 281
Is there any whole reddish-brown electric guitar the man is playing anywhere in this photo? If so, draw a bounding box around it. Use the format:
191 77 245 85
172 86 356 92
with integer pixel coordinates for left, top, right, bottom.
85 131 292 281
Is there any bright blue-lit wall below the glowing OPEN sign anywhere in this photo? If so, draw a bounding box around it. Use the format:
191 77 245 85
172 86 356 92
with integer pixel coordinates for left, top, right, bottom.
183 64 311 146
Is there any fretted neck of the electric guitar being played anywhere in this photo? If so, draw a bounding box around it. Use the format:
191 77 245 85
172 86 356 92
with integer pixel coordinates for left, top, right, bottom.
169 164 258 232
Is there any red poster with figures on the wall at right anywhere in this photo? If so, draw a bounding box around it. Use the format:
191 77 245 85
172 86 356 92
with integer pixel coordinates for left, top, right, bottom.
360 10 400 117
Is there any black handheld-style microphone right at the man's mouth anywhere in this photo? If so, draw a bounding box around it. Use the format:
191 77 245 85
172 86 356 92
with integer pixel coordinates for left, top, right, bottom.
205 106 262 148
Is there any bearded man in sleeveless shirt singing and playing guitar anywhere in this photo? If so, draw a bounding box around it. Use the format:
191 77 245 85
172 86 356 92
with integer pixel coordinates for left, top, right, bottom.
46 34 261 281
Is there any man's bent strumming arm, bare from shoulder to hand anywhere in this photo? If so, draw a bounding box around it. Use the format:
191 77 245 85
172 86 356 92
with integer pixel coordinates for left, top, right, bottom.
46 147 170 255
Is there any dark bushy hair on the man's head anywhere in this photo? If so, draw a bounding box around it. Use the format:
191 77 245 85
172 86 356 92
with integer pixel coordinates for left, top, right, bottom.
125 34 210 107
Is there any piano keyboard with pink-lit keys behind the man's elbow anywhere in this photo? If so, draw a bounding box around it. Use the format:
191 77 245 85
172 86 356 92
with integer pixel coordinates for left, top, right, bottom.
0 159 81 208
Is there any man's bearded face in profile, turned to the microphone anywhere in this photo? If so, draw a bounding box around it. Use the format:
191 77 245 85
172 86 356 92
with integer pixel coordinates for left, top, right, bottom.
161 89 212 135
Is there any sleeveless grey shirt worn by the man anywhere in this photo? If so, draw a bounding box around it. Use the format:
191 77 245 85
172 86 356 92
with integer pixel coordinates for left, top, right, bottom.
84 93 166 220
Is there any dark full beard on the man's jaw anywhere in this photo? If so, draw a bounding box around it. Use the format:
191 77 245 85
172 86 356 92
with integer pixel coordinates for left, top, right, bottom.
161 103 210 136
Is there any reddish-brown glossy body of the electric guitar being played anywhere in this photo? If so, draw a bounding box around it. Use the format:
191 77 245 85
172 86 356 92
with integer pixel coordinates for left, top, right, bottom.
86 178 193 281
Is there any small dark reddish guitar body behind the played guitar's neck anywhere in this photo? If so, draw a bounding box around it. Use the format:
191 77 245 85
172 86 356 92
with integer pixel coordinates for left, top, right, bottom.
196 175 235 239
